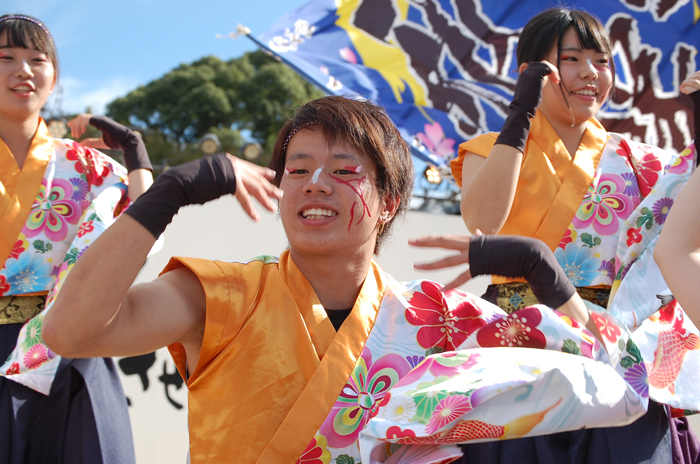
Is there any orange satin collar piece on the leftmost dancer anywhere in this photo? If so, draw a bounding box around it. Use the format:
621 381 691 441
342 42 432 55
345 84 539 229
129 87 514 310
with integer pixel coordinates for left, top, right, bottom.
0 119 53 263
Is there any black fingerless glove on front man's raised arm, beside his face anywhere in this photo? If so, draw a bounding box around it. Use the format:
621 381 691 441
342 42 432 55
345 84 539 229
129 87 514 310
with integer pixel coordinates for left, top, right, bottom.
124 154 236 238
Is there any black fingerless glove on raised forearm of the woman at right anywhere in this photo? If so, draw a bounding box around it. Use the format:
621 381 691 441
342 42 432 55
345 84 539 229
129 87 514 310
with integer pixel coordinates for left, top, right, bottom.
496 62 551 153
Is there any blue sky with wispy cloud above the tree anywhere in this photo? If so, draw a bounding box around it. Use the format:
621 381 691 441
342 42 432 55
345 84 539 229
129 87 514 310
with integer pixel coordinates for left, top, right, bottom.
0 0 308 114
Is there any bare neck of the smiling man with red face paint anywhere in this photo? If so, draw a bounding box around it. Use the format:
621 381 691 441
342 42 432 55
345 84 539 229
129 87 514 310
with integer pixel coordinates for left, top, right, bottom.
290 250 372 309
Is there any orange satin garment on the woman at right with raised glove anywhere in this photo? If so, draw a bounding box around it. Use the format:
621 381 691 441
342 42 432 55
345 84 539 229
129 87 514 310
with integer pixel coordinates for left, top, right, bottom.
451 111 608 283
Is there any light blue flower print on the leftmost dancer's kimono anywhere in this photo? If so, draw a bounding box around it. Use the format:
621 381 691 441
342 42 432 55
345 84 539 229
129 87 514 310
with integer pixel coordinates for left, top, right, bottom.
0 251 54 295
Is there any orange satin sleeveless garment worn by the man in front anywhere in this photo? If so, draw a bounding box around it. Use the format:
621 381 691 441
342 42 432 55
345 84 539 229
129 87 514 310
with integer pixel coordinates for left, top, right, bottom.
164 252 386 464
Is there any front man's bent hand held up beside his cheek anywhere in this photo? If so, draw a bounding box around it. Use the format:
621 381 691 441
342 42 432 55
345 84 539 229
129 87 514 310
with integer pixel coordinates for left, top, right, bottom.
226 153 283 221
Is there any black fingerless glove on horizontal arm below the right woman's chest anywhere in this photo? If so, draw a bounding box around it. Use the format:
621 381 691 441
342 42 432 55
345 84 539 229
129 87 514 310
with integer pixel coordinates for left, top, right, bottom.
469 235 576 308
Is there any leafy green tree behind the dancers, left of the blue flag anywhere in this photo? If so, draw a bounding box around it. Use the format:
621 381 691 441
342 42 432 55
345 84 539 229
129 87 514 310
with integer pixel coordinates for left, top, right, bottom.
107 51 323 164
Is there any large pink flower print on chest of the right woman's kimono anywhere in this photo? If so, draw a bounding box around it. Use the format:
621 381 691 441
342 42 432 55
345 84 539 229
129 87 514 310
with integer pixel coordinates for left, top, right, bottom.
571 174 635 235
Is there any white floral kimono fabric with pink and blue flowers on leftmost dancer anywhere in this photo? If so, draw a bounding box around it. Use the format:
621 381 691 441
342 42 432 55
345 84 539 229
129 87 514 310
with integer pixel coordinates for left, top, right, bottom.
0 139 128 395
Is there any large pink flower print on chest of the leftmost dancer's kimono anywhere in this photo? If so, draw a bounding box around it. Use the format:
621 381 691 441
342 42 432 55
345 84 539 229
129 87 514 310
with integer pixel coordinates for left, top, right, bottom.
24 179 81 242
